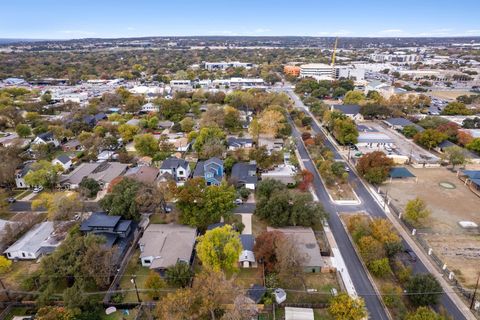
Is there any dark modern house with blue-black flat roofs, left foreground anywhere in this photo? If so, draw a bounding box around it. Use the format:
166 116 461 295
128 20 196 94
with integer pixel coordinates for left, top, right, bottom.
80 212 137 259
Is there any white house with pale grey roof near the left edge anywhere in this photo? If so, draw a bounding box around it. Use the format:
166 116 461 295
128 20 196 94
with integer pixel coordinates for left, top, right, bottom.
4 221 61 260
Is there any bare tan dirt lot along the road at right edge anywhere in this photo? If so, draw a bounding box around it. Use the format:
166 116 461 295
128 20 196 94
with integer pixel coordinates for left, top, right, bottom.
382 167 480 286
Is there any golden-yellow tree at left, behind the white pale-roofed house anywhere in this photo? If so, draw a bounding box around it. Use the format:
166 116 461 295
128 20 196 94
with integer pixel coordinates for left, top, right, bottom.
32 191 82 221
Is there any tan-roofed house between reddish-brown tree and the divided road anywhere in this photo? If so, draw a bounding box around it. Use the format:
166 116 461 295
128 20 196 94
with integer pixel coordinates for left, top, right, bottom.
267 227 325 273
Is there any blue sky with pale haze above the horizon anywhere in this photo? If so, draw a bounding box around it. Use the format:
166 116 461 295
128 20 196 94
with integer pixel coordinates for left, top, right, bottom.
0 0 480 39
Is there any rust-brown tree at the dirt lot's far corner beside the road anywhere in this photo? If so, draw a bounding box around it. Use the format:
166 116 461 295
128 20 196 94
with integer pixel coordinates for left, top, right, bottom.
357 151 393 184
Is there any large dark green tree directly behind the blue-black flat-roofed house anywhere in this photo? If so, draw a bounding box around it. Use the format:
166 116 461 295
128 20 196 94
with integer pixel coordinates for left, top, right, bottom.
99 178 140 220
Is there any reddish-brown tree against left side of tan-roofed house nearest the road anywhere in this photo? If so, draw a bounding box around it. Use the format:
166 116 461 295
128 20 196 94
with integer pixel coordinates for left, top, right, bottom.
253 231 285 272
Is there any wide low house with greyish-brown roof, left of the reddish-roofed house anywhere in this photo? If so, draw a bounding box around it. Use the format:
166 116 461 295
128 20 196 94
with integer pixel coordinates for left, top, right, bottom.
60 162 128 189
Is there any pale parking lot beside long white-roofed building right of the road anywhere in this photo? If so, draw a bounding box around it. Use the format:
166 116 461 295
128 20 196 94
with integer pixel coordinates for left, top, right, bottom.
359 121 440 164
